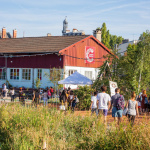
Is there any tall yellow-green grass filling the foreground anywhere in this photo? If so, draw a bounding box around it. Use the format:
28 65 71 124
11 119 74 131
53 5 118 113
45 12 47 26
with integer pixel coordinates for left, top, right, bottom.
0 104 150 150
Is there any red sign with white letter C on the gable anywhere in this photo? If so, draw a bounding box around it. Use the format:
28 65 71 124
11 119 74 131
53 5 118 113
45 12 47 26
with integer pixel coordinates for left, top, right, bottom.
85 46 95 63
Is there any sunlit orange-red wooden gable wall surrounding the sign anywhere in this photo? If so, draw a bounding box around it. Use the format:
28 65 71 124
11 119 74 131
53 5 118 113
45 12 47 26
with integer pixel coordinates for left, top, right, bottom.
62 38 109 68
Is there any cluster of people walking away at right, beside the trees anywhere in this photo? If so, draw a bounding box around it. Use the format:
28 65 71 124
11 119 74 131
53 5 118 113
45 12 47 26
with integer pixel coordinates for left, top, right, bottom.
91 86 150 125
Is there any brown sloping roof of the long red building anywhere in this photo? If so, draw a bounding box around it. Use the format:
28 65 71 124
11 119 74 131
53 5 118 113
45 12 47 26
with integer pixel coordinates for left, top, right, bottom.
0 35 88 53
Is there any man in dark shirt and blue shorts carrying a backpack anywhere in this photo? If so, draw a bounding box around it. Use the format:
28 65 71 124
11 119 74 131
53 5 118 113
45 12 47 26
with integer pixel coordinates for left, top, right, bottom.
110 88 124 125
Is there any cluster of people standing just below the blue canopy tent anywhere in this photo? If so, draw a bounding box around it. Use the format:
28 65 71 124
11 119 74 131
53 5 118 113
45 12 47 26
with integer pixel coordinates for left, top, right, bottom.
60 88 79 111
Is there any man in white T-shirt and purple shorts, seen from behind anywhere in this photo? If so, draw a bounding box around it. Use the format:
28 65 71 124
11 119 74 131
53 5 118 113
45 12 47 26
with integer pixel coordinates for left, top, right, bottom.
97 85 111 122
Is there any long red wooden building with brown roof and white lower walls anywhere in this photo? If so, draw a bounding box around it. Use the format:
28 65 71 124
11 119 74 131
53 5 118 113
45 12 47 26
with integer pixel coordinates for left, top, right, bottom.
0 35 112 87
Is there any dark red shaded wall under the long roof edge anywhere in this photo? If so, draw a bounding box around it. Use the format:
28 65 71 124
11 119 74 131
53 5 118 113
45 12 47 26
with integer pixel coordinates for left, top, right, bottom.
0 54 63 68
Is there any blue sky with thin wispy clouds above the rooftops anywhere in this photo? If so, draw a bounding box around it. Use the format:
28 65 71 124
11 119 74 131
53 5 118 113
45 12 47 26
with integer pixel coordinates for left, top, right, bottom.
0 0 150 40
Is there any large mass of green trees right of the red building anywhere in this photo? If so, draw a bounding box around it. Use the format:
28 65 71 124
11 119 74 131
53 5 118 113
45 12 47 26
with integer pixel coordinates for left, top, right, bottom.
94 31 150 99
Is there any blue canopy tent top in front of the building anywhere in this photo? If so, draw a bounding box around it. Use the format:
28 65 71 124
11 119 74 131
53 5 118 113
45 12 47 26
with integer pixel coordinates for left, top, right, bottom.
58 71 93 85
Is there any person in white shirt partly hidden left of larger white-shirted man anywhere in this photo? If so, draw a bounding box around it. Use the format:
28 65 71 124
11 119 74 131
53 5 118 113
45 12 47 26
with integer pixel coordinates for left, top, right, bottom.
91 92 98 115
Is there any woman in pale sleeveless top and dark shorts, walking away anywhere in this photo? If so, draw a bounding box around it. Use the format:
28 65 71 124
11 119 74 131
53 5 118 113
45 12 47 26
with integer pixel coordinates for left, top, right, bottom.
126 92 139 126
